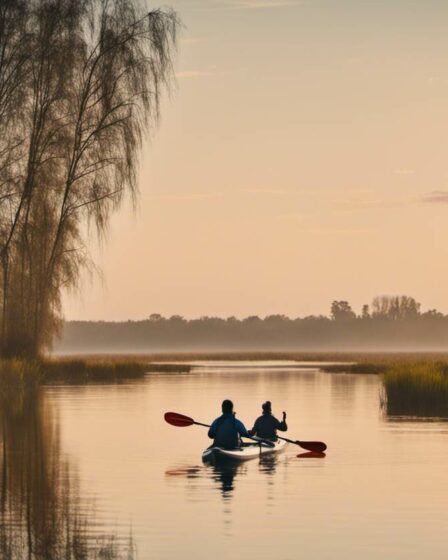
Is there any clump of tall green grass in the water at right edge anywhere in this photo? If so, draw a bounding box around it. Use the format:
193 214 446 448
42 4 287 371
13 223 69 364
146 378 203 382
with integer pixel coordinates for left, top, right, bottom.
383 362 448 417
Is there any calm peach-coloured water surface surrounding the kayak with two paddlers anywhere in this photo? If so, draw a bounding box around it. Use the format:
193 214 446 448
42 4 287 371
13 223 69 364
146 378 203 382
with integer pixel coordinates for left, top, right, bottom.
0 363 448 560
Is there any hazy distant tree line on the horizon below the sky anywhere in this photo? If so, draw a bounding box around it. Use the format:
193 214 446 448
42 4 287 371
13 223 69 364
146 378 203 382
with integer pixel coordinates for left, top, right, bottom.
55 296 448 353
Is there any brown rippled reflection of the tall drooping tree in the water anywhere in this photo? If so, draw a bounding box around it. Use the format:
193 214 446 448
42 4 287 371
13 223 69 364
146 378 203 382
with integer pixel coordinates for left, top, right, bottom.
0 386 134 560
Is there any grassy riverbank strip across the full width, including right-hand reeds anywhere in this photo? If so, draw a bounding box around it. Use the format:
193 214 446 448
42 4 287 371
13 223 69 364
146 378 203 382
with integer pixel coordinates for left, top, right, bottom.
0 352 448 417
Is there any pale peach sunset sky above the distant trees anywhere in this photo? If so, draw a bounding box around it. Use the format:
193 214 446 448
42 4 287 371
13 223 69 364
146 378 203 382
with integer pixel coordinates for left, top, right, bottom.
63 0 448 320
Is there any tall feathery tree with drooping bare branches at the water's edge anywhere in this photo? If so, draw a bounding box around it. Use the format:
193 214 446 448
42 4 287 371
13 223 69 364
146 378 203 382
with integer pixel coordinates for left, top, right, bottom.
0 0 178 356
